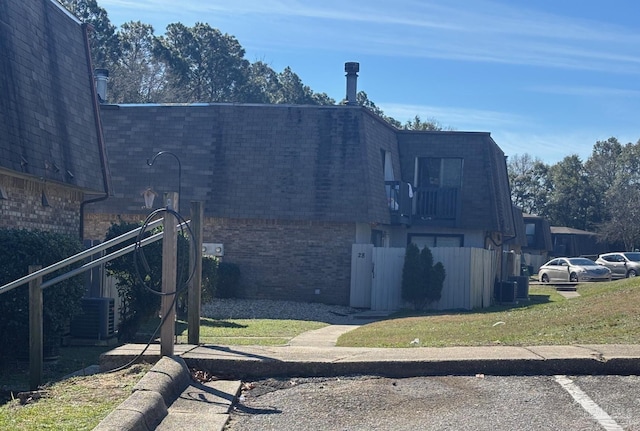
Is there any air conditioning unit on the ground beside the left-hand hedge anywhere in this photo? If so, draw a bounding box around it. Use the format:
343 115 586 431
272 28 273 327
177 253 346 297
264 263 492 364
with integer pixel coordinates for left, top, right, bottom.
71 298 115 340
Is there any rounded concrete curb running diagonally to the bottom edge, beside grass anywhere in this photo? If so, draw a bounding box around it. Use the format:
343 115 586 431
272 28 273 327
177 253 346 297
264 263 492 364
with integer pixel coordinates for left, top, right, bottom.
94 356 191 431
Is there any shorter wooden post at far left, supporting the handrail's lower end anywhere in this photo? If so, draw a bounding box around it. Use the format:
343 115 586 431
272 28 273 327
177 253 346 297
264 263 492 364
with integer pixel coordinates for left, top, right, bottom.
29 265 43 391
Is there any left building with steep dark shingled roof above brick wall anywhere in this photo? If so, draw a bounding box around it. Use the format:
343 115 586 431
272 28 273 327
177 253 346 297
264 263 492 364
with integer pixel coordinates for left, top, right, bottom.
0 0 109 237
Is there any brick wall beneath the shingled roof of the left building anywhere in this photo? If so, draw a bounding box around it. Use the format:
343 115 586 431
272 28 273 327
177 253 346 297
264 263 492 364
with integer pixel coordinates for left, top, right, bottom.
0 174 83 236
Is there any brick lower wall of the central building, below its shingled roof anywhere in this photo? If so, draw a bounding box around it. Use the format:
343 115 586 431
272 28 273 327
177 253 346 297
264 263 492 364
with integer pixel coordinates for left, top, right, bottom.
85 214 355 305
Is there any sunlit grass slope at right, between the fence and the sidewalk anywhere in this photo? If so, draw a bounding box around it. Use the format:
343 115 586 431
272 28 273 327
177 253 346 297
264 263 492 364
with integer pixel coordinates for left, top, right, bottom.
338 278 640 347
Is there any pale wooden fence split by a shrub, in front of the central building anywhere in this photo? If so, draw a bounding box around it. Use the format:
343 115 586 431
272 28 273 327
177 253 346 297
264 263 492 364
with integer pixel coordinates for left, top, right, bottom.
350 244 499 311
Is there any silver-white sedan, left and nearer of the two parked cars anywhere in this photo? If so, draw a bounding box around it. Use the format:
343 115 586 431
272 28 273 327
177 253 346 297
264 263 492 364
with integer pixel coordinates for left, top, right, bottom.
538 257 611 283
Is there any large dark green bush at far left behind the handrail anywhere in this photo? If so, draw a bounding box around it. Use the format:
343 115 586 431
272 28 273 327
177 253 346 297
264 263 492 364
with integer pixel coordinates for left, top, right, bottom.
0 229 85 362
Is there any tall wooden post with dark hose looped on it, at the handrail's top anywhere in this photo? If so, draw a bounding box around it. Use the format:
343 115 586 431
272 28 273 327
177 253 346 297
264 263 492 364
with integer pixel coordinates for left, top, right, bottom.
160 192 179 356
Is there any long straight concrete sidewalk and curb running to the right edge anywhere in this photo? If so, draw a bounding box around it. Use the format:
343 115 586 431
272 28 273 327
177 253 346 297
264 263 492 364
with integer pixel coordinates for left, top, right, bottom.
101 345 640 379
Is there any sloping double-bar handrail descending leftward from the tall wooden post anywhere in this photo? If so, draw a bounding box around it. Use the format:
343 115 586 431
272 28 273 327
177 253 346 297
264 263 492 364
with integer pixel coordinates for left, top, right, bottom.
0 219 190 294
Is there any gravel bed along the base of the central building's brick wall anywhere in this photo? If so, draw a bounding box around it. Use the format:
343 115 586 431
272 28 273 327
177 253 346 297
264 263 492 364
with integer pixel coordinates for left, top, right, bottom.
201 298 362 325
